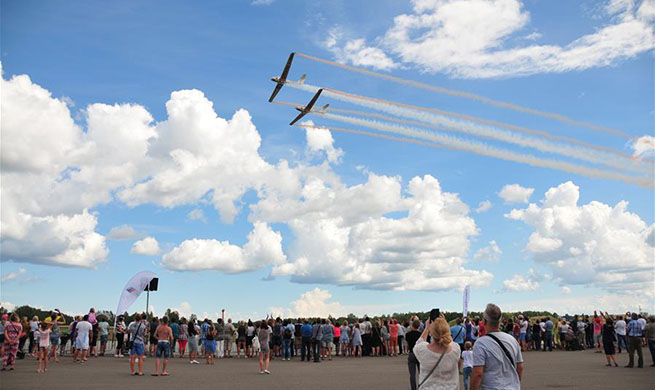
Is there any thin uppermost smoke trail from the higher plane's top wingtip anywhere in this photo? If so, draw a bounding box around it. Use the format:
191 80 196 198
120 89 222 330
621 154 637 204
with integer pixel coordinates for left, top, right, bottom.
296 52 632 138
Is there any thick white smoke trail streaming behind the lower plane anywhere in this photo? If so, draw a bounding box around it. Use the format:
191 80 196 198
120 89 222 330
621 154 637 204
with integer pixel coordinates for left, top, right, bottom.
310 114 655 188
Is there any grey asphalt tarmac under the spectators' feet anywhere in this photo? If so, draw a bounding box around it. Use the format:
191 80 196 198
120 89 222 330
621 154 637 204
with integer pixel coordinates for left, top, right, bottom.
0 349 655 390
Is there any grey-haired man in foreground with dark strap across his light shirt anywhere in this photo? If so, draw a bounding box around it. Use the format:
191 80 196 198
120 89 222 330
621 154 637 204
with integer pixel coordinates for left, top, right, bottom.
471 303 523 390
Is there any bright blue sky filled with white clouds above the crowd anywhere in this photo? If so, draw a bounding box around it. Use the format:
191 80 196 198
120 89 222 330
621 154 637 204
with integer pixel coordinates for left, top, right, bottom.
1 0 655 317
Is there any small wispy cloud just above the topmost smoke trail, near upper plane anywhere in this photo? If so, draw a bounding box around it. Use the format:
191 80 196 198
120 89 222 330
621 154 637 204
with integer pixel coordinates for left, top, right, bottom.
325 27 399 70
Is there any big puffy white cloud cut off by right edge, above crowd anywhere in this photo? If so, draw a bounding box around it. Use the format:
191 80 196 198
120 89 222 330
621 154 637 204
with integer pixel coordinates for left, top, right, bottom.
505 181 655 299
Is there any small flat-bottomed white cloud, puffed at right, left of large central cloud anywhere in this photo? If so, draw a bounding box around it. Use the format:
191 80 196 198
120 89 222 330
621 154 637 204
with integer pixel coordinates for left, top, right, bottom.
161 222 286 273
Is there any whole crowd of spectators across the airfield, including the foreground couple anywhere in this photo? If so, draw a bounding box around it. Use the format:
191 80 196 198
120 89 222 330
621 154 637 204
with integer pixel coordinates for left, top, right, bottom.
0 304 655 390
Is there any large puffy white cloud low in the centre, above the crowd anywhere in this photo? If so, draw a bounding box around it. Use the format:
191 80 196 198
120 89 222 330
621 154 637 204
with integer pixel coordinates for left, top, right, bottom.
258 174 493 290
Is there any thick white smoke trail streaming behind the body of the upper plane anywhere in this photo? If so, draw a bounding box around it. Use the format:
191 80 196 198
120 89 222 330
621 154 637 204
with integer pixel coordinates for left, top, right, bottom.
288 82 652 173
